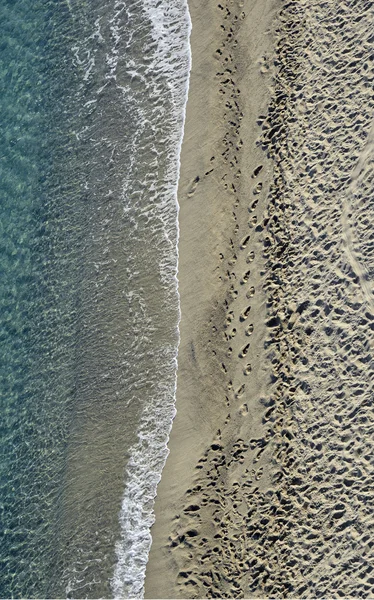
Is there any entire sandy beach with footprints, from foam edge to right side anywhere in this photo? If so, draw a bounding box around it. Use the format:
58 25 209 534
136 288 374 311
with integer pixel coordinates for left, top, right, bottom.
145 0 374 598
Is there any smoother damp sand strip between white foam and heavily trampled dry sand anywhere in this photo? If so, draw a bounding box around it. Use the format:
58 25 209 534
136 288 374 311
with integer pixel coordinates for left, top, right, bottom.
145 0 275 598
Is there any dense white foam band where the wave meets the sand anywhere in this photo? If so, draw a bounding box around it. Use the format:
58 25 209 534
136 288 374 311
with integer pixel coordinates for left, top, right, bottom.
111 0 191 598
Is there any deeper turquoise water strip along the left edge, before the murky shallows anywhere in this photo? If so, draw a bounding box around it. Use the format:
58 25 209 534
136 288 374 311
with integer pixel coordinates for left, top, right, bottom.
0 2 76 597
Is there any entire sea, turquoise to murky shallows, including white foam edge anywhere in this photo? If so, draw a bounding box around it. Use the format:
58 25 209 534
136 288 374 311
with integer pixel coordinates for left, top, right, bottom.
0 0 190 598
